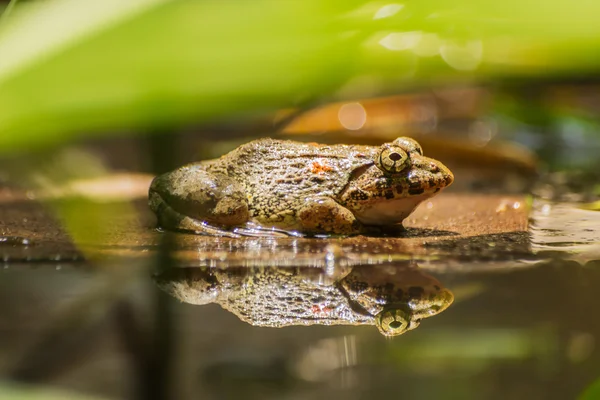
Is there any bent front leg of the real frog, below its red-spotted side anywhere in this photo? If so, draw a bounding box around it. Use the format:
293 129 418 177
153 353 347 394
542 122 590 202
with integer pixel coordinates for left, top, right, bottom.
297 197 365 235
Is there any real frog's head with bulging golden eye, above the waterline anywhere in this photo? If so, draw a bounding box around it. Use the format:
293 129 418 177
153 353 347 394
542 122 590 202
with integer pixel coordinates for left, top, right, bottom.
339 137 454 225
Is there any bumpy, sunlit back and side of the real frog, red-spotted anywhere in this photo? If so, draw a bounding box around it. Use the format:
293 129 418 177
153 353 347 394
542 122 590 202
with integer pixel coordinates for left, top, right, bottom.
207 139 376 222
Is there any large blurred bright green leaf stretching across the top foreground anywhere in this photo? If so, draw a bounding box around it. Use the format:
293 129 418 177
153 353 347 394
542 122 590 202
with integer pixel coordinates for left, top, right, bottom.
0 0 600 152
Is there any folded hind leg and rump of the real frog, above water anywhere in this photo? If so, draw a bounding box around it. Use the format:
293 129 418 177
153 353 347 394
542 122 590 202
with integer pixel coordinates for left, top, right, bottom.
149 164 249 237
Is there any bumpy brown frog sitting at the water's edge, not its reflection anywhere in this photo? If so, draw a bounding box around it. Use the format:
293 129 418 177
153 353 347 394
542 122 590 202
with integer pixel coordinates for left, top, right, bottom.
149 137 454 238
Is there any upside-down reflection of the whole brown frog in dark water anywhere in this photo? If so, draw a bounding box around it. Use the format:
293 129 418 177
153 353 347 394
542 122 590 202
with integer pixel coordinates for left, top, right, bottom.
156 264 454 336
